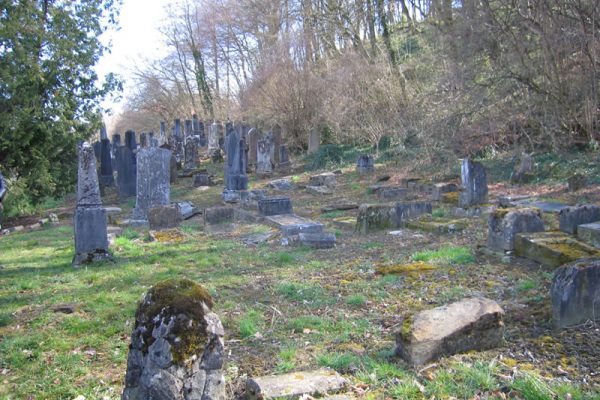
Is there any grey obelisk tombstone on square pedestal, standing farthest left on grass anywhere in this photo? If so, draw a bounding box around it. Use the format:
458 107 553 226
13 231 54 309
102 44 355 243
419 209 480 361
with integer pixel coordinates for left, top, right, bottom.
73 142 112 266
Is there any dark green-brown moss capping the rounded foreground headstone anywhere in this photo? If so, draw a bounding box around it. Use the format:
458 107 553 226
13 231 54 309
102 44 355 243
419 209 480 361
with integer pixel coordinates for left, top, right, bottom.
136 279 213 365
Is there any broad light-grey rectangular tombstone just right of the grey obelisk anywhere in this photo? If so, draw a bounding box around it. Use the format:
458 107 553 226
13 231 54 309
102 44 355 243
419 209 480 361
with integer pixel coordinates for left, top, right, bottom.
133 148 171 220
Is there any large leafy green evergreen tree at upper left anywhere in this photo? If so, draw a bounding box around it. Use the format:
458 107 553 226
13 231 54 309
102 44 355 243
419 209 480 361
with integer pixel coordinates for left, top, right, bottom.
0 0 119 203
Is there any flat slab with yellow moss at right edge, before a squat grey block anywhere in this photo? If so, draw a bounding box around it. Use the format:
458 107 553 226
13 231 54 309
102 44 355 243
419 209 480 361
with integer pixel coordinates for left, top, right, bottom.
515 231 600 267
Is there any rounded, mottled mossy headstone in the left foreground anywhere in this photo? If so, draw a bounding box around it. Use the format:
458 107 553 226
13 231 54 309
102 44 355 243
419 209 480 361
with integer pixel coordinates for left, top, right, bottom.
122 279 226 400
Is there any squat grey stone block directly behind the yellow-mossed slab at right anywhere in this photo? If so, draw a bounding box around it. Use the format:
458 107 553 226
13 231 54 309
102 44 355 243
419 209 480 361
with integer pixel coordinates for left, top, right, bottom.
488 208 544 251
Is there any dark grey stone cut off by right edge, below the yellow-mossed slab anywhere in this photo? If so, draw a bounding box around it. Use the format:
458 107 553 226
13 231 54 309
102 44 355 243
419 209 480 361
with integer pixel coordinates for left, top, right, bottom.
550 258 600 328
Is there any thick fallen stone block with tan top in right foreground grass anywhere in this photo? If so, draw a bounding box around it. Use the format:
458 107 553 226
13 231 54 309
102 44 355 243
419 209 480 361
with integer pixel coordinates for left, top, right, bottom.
396 298 504 365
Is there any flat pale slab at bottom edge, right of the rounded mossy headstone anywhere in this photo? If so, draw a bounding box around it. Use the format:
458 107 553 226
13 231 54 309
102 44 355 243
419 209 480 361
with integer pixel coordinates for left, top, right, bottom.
246 369 348 400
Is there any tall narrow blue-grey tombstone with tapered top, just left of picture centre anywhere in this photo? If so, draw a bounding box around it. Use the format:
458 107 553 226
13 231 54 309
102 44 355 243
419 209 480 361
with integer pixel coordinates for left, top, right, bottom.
223 131 248 201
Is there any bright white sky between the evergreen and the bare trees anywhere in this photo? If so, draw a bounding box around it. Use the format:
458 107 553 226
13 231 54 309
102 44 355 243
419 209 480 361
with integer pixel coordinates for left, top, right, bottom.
96 0 177 125
